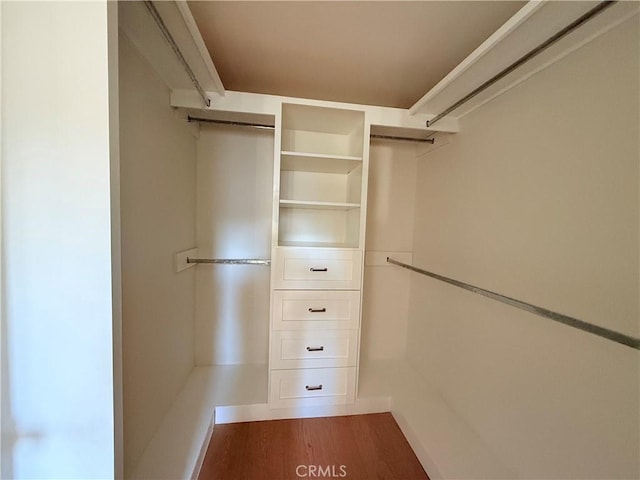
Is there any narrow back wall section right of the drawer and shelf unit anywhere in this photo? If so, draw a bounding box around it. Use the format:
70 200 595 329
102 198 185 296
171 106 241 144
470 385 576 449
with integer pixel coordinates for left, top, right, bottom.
360 140 418 359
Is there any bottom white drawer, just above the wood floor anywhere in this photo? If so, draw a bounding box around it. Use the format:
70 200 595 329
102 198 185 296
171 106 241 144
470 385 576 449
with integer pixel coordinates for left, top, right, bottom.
270 367 356 408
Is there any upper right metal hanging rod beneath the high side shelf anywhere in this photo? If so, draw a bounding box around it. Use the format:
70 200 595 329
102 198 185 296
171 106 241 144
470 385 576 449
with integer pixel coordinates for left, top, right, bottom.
427 1 617 127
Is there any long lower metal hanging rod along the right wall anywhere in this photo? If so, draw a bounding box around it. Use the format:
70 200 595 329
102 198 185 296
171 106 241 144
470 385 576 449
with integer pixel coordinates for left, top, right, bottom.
387 257 640 350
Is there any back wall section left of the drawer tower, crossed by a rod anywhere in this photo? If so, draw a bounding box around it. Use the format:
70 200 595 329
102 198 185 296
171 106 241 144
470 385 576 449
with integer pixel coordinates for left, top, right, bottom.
196 125 273 365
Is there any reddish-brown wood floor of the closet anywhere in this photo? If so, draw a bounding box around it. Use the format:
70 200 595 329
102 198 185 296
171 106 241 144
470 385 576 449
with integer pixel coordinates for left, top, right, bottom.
198 413 428 480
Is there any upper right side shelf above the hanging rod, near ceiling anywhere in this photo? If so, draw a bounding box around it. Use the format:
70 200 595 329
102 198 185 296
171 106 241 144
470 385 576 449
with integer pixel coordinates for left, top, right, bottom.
409 1 640 118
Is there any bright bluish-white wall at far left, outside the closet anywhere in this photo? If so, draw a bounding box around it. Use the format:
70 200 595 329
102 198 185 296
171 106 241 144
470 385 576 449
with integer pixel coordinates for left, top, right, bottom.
0 2 118 479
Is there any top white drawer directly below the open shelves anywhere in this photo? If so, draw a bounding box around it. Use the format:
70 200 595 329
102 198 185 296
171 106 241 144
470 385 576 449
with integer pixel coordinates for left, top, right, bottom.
273 247 362 290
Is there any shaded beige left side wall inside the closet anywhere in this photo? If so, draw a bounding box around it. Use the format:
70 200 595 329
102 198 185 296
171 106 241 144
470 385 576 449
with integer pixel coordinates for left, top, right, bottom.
119 34 196 476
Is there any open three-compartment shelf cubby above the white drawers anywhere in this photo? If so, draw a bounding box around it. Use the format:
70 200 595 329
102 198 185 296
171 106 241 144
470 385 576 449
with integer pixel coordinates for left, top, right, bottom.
277 103 365 248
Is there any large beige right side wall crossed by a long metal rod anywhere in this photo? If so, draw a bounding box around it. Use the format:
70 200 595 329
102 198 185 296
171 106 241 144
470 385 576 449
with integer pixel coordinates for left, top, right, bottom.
408 16 640 478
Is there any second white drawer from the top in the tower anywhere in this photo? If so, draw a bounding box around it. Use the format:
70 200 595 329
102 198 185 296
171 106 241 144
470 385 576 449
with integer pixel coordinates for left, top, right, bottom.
272 290 360 330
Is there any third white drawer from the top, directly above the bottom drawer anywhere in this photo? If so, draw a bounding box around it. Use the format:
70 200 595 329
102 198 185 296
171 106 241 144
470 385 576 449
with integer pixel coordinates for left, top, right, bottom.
270 330 358 368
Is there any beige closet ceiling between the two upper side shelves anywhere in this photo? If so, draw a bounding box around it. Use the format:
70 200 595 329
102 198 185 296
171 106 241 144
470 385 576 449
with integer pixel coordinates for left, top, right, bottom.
189 1 526 108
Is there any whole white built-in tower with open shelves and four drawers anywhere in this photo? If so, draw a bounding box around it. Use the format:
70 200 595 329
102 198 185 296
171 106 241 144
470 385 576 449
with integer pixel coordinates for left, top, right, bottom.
269 103 369 411
